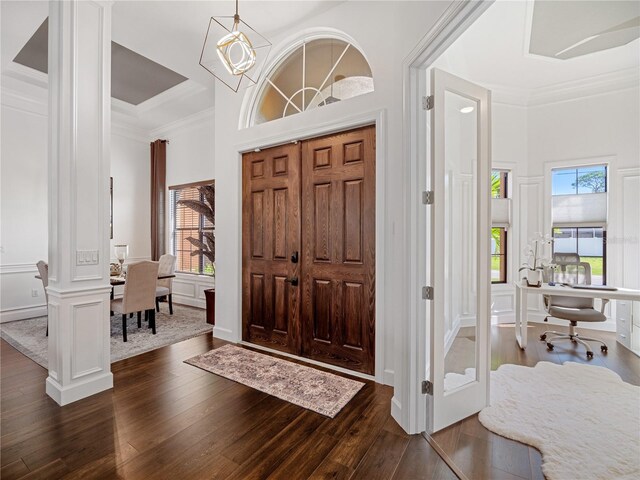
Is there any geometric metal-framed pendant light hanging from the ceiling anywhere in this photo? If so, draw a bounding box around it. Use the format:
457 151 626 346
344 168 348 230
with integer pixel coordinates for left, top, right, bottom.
200 0 271 92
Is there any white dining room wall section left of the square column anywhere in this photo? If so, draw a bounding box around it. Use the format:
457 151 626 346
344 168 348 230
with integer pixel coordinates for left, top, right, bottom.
0 92 48 321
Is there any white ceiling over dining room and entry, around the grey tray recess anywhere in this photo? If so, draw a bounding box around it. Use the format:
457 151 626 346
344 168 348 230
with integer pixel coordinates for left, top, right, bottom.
0 0 343 129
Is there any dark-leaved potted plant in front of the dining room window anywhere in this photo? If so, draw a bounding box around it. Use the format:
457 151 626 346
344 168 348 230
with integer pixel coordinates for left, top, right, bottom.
178 184 216 325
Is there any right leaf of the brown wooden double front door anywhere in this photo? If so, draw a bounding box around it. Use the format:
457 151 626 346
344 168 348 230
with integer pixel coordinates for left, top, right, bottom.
302 126 375 374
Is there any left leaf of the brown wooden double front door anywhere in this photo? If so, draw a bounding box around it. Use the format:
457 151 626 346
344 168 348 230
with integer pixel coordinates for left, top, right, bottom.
242 145 300 354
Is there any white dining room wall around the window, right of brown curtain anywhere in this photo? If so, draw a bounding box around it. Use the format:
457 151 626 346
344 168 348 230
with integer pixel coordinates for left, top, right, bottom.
151 109 216 308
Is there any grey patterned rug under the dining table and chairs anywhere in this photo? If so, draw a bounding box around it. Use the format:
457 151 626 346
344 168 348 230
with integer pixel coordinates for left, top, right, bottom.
0 304 212 368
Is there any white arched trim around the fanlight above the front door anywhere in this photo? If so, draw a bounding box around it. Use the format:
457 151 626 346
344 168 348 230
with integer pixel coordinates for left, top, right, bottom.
244 28 375 129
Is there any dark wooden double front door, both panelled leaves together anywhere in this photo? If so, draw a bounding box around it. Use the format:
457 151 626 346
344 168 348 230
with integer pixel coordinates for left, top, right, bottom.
242 126 375 374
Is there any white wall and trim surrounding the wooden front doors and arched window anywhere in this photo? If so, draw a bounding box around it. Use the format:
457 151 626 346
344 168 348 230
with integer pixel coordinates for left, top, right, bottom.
214 2 448 432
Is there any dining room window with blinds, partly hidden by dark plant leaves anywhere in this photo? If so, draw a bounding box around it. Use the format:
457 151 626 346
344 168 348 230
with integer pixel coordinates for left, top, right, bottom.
169 181 214 275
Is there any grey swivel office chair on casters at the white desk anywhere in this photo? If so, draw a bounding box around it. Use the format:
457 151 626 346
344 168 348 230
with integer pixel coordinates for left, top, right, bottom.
540 253 608 358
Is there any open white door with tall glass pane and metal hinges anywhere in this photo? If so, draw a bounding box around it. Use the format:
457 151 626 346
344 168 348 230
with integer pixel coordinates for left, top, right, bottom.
427 69 491 433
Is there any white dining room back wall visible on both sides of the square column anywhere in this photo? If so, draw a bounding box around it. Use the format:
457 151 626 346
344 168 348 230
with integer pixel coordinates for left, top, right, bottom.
0 89 150 322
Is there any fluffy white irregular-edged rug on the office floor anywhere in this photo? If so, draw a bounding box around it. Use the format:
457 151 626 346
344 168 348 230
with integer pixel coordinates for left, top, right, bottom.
479 362 640 480
